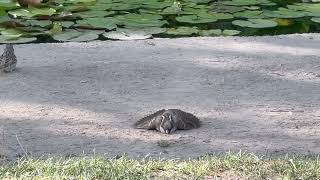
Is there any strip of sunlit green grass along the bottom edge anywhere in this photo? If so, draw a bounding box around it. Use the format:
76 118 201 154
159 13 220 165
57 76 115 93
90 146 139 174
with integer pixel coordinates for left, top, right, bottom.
0 153 320 179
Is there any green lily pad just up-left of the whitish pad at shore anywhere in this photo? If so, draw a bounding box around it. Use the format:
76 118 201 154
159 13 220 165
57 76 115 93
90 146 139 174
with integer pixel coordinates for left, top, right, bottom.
76 17 117 30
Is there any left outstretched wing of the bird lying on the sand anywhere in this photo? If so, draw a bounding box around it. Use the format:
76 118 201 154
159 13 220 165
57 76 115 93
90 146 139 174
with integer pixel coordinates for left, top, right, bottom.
134 109 166 129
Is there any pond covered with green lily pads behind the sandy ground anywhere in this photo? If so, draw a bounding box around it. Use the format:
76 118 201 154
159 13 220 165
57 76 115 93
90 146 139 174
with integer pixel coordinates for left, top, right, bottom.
0 0 320 43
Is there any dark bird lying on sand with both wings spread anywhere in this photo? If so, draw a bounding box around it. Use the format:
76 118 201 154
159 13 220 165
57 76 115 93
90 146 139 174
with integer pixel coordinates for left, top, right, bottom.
134 109 200 134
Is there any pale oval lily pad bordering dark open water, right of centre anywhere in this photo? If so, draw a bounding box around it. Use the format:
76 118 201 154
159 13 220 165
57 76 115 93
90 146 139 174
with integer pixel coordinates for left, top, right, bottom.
232 19 278 28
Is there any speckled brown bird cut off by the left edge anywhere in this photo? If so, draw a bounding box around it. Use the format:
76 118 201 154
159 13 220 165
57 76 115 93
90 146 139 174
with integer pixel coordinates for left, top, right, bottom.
0 44 17 73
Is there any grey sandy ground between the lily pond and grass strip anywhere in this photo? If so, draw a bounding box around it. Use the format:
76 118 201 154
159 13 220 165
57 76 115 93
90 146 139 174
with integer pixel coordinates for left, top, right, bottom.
0 34 320 158
